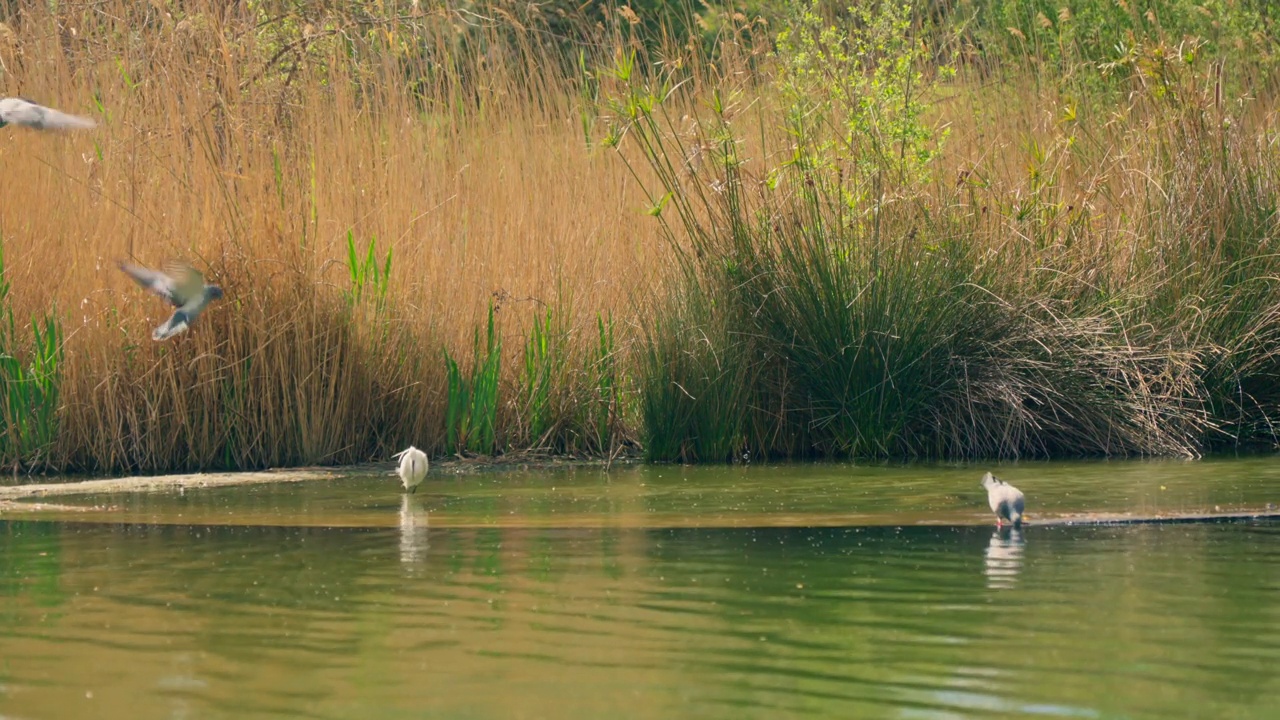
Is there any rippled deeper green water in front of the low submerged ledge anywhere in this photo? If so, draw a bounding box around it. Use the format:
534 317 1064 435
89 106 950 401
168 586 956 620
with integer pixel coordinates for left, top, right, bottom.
0 502 1280 719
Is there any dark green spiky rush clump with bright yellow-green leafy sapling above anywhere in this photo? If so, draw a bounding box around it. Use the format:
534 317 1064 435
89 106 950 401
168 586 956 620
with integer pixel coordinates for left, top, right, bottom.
614 4 998 460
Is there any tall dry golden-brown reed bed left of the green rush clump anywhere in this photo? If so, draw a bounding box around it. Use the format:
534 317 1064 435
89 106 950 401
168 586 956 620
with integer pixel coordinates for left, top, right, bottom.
0 1 663 470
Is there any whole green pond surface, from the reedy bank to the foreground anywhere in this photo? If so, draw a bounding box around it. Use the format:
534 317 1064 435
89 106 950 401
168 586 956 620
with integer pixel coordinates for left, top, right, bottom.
0 457 1280 719
